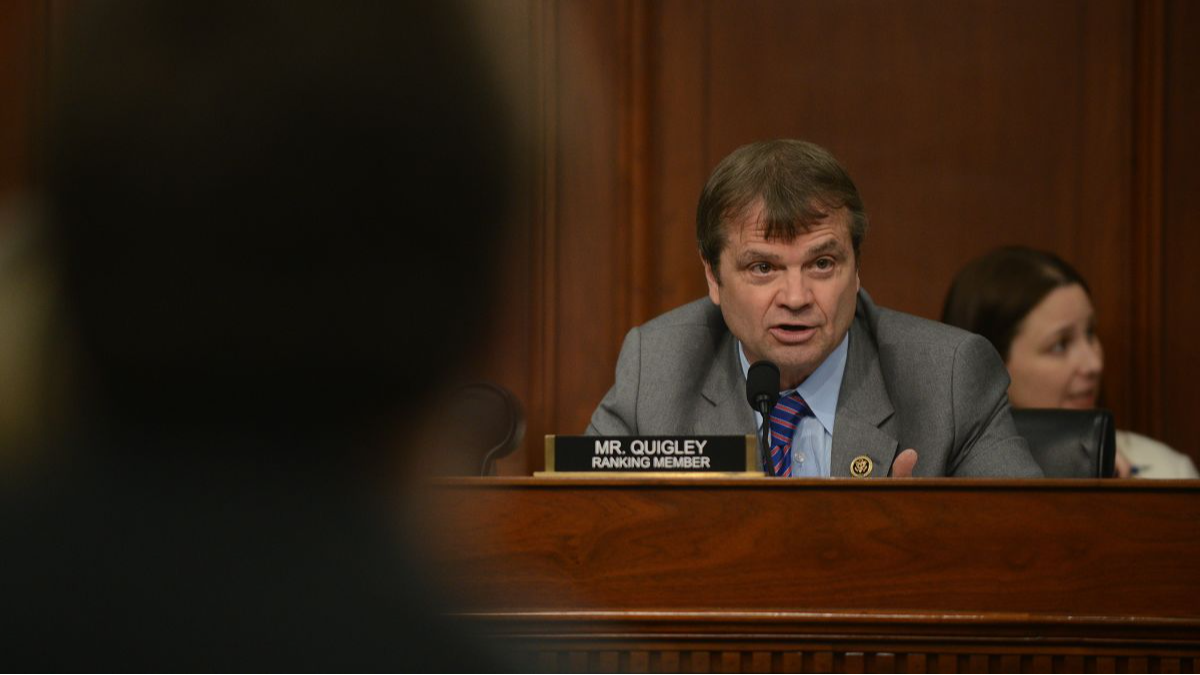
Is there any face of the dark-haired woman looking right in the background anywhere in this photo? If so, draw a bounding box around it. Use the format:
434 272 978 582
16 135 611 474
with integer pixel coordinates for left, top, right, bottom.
1007 283 1104 408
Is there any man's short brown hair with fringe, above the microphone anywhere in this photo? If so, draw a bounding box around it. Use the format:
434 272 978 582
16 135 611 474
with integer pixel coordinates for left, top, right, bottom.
696 139 868 279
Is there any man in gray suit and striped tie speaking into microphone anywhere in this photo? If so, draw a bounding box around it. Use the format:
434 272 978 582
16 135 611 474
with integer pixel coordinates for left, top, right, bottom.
587 141 1042 477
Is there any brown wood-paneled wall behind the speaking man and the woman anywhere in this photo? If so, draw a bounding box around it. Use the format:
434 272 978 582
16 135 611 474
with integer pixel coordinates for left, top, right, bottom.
480 0 1200 473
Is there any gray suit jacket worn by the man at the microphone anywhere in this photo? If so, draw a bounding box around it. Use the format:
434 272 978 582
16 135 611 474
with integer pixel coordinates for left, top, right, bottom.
587 292 1042 478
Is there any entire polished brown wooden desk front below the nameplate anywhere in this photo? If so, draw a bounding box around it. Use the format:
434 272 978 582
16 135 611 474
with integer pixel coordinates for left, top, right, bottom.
434 478 1200 673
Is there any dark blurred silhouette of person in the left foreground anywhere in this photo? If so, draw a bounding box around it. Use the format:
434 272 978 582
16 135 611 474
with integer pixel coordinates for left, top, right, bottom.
0 0 515 671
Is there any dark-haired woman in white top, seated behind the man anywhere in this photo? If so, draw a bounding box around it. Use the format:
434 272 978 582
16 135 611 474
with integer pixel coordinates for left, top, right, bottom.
942 247 1200 478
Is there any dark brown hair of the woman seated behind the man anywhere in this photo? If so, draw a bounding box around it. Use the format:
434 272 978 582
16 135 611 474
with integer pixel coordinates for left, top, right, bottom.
942 246 1091 362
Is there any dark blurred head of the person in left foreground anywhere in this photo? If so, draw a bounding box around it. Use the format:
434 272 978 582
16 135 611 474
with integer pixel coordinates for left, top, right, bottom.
47 0 510 449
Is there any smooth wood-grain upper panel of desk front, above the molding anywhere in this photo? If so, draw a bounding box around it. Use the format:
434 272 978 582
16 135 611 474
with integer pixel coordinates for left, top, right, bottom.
429 480 1200 619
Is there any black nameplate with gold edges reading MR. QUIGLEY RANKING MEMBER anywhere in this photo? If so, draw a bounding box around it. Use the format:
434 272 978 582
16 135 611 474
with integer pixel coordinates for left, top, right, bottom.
546 436 762 476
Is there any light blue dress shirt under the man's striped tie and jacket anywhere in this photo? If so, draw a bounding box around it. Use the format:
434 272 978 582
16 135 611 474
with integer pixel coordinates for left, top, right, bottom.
738 330 850 478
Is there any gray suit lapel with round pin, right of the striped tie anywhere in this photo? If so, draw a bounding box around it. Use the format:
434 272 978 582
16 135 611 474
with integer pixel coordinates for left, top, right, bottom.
829 302 896 478
